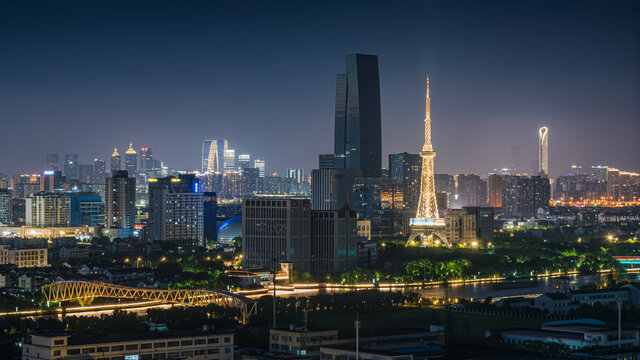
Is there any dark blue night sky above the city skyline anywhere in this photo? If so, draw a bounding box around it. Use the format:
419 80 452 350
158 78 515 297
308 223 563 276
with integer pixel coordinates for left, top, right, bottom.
0 0 640 176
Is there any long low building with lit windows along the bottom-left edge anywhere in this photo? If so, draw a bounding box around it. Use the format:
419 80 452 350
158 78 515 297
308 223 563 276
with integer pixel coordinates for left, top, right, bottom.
22 330 234 360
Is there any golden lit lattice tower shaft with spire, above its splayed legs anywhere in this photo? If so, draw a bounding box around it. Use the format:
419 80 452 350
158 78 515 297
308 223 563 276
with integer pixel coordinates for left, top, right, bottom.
416 76 438 219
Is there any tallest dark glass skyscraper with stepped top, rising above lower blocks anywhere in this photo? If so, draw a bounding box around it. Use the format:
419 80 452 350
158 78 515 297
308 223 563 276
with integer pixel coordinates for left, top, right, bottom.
334 54 382 177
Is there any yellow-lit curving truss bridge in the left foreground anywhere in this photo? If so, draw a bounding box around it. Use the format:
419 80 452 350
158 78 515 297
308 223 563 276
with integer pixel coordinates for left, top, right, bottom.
42 281 257 324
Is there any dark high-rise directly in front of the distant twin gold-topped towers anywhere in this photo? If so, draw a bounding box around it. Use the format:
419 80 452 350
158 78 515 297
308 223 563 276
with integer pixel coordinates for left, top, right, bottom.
104 170 136 229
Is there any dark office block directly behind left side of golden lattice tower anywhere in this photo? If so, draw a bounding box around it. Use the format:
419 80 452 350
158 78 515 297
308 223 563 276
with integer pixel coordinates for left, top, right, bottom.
389 152 422 212
